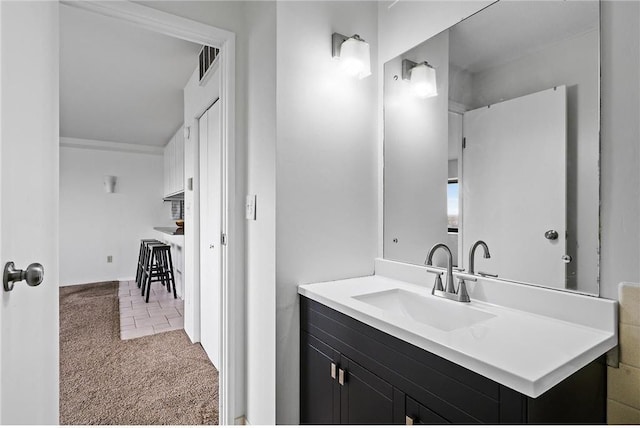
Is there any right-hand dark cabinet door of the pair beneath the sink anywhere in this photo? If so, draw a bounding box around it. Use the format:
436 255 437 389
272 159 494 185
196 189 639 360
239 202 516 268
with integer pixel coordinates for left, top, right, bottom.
338 356 394 425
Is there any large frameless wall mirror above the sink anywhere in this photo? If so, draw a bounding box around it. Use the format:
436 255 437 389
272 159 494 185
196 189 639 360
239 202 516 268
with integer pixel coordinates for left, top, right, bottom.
384 0 600 295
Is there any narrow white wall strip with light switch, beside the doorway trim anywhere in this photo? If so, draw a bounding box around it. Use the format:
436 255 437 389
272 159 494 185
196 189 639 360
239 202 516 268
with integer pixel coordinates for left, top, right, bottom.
246 2 276 424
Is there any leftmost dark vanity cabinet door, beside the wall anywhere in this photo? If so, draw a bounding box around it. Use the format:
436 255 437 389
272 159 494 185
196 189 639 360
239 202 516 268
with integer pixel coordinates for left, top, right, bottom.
300 331 340 425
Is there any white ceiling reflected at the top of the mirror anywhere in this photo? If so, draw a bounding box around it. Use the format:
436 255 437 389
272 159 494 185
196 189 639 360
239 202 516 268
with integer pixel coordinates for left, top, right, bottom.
449 1 599 73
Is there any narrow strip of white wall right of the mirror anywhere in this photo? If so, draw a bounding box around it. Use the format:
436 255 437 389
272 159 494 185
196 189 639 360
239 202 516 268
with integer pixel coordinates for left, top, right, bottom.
600 1 640 299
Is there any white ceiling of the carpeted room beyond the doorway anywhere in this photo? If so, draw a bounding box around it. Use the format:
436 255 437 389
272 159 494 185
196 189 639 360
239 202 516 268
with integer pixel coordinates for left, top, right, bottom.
60 5 200 146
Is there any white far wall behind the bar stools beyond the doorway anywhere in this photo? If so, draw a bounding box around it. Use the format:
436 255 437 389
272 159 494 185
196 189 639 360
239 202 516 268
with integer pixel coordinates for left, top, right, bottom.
60 147 172 286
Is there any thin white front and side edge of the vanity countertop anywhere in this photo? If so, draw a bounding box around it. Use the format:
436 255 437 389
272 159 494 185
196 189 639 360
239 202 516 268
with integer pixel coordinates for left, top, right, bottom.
298 285 617 398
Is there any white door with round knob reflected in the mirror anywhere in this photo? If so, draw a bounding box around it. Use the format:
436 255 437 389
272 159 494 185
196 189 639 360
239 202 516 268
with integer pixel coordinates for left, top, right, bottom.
462 86 567 288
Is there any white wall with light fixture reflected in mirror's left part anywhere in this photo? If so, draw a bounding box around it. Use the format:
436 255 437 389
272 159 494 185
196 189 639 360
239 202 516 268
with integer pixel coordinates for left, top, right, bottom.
381 31 449 266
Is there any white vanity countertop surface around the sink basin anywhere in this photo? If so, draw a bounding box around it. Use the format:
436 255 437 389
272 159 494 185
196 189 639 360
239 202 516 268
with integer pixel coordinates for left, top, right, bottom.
298 275 618 398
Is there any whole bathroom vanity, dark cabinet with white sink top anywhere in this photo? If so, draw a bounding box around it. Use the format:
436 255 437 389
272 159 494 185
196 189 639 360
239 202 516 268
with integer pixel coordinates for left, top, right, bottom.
299 271 617 424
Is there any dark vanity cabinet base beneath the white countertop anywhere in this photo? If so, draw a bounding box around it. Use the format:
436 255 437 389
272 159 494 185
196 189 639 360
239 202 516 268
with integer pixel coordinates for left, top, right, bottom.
300 296 606 425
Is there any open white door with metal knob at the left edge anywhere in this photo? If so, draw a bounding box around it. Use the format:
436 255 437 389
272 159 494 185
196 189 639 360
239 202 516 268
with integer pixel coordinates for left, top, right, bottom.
0 1 59 425
